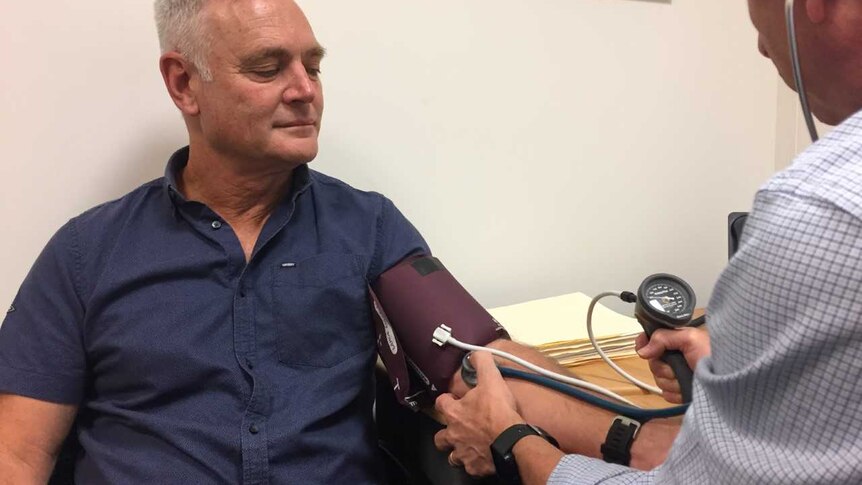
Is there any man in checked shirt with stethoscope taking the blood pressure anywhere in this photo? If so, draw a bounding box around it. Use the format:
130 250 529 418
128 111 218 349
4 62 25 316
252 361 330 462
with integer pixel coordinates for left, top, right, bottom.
436 0 862 484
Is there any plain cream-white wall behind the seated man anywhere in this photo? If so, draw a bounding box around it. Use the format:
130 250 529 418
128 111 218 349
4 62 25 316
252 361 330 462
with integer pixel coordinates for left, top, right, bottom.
0 0 778 314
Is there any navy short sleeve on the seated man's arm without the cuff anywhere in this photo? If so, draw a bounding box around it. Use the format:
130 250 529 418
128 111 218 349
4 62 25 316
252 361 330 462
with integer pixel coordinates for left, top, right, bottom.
0 222 86 404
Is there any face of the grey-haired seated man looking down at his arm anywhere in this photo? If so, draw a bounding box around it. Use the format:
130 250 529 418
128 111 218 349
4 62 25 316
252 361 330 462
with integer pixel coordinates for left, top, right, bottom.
197 0 323 168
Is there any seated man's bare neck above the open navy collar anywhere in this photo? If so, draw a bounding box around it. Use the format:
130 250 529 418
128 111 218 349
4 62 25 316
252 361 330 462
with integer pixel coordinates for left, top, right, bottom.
177 149 294 260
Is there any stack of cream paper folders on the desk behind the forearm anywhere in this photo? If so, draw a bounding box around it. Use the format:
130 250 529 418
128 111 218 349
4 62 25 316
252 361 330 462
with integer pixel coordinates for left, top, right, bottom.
488 293 643 367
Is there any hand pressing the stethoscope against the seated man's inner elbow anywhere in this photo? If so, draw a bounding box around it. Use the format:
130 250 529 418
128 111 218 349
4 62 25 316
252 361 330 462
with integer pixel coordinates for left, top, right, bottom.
434 352 525 476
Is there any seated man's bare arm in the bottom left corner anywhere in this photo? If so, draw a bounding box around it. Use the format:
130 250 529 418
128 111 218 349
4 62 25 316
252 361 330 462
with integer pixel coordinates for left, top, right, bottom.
0 394 78 485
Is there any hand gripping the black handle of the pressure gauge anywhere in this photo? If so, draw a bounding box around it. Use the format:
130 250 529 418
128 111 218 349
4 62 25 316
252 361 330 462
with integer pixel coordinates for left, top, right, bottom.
635 327 710 404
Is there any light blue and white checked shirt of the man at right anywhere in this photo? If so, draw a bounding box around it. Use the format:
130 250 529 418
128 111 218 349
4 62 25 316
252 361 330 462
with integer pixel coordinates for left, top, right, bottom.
549 110 862 485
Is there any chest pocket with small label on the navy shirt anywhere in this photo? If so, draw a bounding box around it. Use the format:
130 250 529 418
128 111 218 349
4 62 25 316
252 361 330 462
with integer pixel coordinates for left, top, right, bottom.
272 253 374 367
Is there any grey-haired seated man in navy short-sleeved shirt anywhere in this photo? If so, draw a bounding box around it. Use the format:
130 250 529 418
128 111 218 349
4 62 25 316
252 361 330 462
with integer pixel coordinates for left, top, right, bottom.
0 0 428 485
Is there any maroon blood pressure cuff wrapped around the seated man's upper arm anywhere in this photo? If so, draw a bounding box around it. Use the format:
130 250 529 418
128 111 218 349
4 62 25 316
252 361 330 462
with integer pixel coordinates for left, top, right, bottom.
369 256 509 410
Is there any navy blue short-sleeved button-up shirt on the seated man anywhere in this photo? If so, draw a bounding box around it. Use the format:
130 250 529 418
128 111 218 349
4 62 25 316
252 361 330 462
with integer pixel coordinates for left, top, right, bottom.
0 149 428 484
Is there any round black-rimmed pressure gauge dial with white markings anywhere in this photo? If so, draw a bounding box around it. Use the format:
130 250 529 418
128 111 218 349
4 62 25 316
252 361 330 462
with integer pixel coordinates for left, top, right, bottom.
635 273 695 328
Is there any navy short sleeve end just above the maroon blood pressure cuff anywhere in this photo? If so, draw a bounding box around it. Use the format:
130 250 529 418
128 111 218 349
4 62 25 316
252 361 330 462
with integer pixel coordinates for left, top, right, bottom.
369 197 431 282
